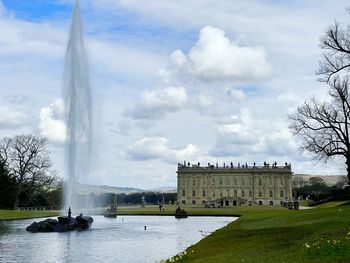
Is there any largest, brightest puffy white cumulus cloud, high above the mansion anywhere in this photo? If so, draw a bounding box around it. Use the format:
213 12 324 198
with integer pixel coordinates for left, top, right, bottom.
188 26 271 81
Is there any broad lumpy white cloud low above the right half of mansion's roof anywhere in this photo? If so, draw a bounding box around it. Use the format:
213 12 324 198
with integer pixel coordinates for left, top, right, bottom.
211 108 298 158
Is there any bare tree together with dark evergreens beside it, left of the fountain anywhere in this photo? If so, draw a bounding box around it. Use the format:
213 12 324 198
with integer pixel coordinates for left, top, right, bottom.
0 135 62 208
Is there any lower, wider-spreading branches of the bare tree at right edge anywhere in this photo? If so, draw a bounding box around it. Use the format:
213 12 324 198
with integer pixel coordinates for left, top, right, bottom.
289 77 350 184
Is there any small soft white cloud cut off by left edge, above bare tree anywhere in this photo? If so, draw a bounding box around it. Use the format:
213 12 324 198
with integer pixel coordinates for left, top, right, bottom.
0 106 27 128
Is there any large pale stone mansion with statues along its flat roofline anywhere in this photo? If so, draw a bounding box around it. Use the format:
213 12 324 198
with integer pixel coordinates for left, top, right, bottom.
177 162 292 206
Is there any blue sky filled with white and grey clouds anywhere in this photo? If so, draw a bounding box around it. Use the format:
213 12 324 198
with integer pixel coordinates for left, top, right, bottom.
0 0 349 189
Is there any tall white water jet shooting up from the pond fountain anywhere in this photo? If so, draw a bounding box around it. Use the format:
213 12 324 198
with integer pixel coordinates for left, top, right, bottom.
64 0 92 210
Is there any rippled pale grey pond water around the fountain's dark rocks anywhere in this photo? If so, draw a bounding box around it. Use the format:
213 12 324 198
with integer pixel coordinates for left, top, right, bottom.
0 216 237 263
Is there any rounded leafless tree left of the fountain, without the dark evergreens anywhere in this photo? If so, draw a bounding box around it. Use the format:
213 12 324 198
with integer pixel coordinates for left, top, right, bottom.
0 135 56 206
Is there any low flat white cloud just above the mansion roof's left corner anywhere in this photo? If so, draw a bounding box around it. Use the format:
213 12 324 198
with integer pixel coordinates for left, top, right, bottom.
127 137 199 163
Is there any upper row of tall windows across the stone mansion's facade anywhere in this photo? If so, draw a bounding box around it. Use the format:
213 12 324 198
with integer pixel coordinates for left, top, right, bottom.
182 177 285 186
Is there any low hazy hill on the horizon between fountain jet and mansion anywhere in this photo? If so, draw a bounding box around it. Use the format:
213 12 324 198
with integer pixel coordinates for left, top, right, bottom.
77 184 176 194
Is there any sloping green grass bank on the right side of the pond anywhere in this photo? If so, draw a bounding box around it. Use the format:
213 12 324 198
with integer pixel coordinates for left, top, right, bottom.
163 203 350 263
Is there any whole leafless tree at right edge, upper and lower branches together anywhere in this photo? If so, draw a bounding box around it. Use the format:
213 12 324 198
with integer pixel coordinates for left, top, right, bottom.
289 16 350 186
